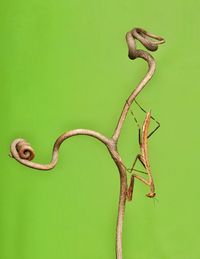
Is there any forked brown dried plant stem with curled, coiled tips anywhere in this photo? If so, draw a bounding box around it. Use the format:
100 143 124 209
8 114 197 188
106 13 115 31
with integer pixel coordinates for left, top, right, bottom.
11 28 164 259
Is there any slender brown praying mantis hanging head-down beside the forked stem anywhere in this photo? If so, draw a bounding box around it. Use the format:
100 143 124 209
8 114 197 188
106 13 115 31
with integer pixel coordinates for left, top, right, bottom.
127 100 160 201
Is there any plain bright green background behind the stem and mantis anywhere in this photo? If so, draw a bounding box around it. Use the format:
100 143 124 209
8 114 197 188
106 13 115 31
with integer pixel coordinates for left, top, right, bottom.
0 0 200 259
